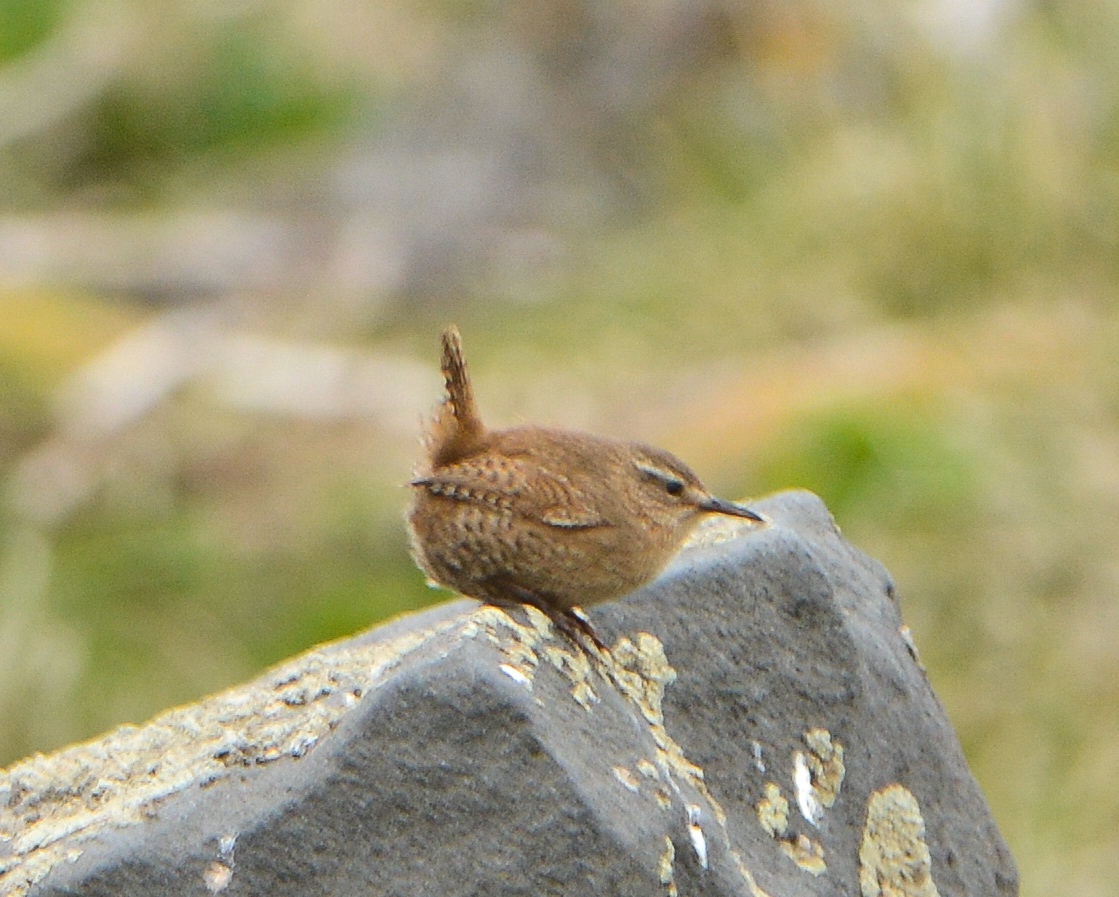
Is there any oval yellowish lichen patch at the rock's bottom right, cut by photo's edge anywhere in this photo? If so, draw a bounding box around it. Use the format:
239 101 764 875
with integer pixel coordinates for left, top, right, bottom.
858 784 938 897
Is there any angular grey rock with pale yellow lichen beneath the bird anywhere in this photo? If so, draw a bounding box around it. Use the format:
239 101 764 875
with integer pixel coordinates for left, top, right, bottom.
0 492 1017 897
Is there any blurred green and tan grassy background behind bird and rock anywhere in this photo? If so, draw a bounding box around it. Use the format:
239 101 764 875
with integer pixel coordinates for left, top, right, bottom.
0 0 1119 897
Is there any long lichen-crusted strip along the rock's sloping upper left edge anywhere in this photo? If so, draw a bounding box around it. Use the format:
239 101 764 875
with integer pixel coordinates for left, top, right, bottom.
0 620 458 895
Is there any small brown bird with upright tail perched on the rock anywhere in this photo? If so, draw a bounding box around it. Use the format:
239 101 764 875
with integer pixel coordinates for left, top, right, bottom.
408 325 762 646
